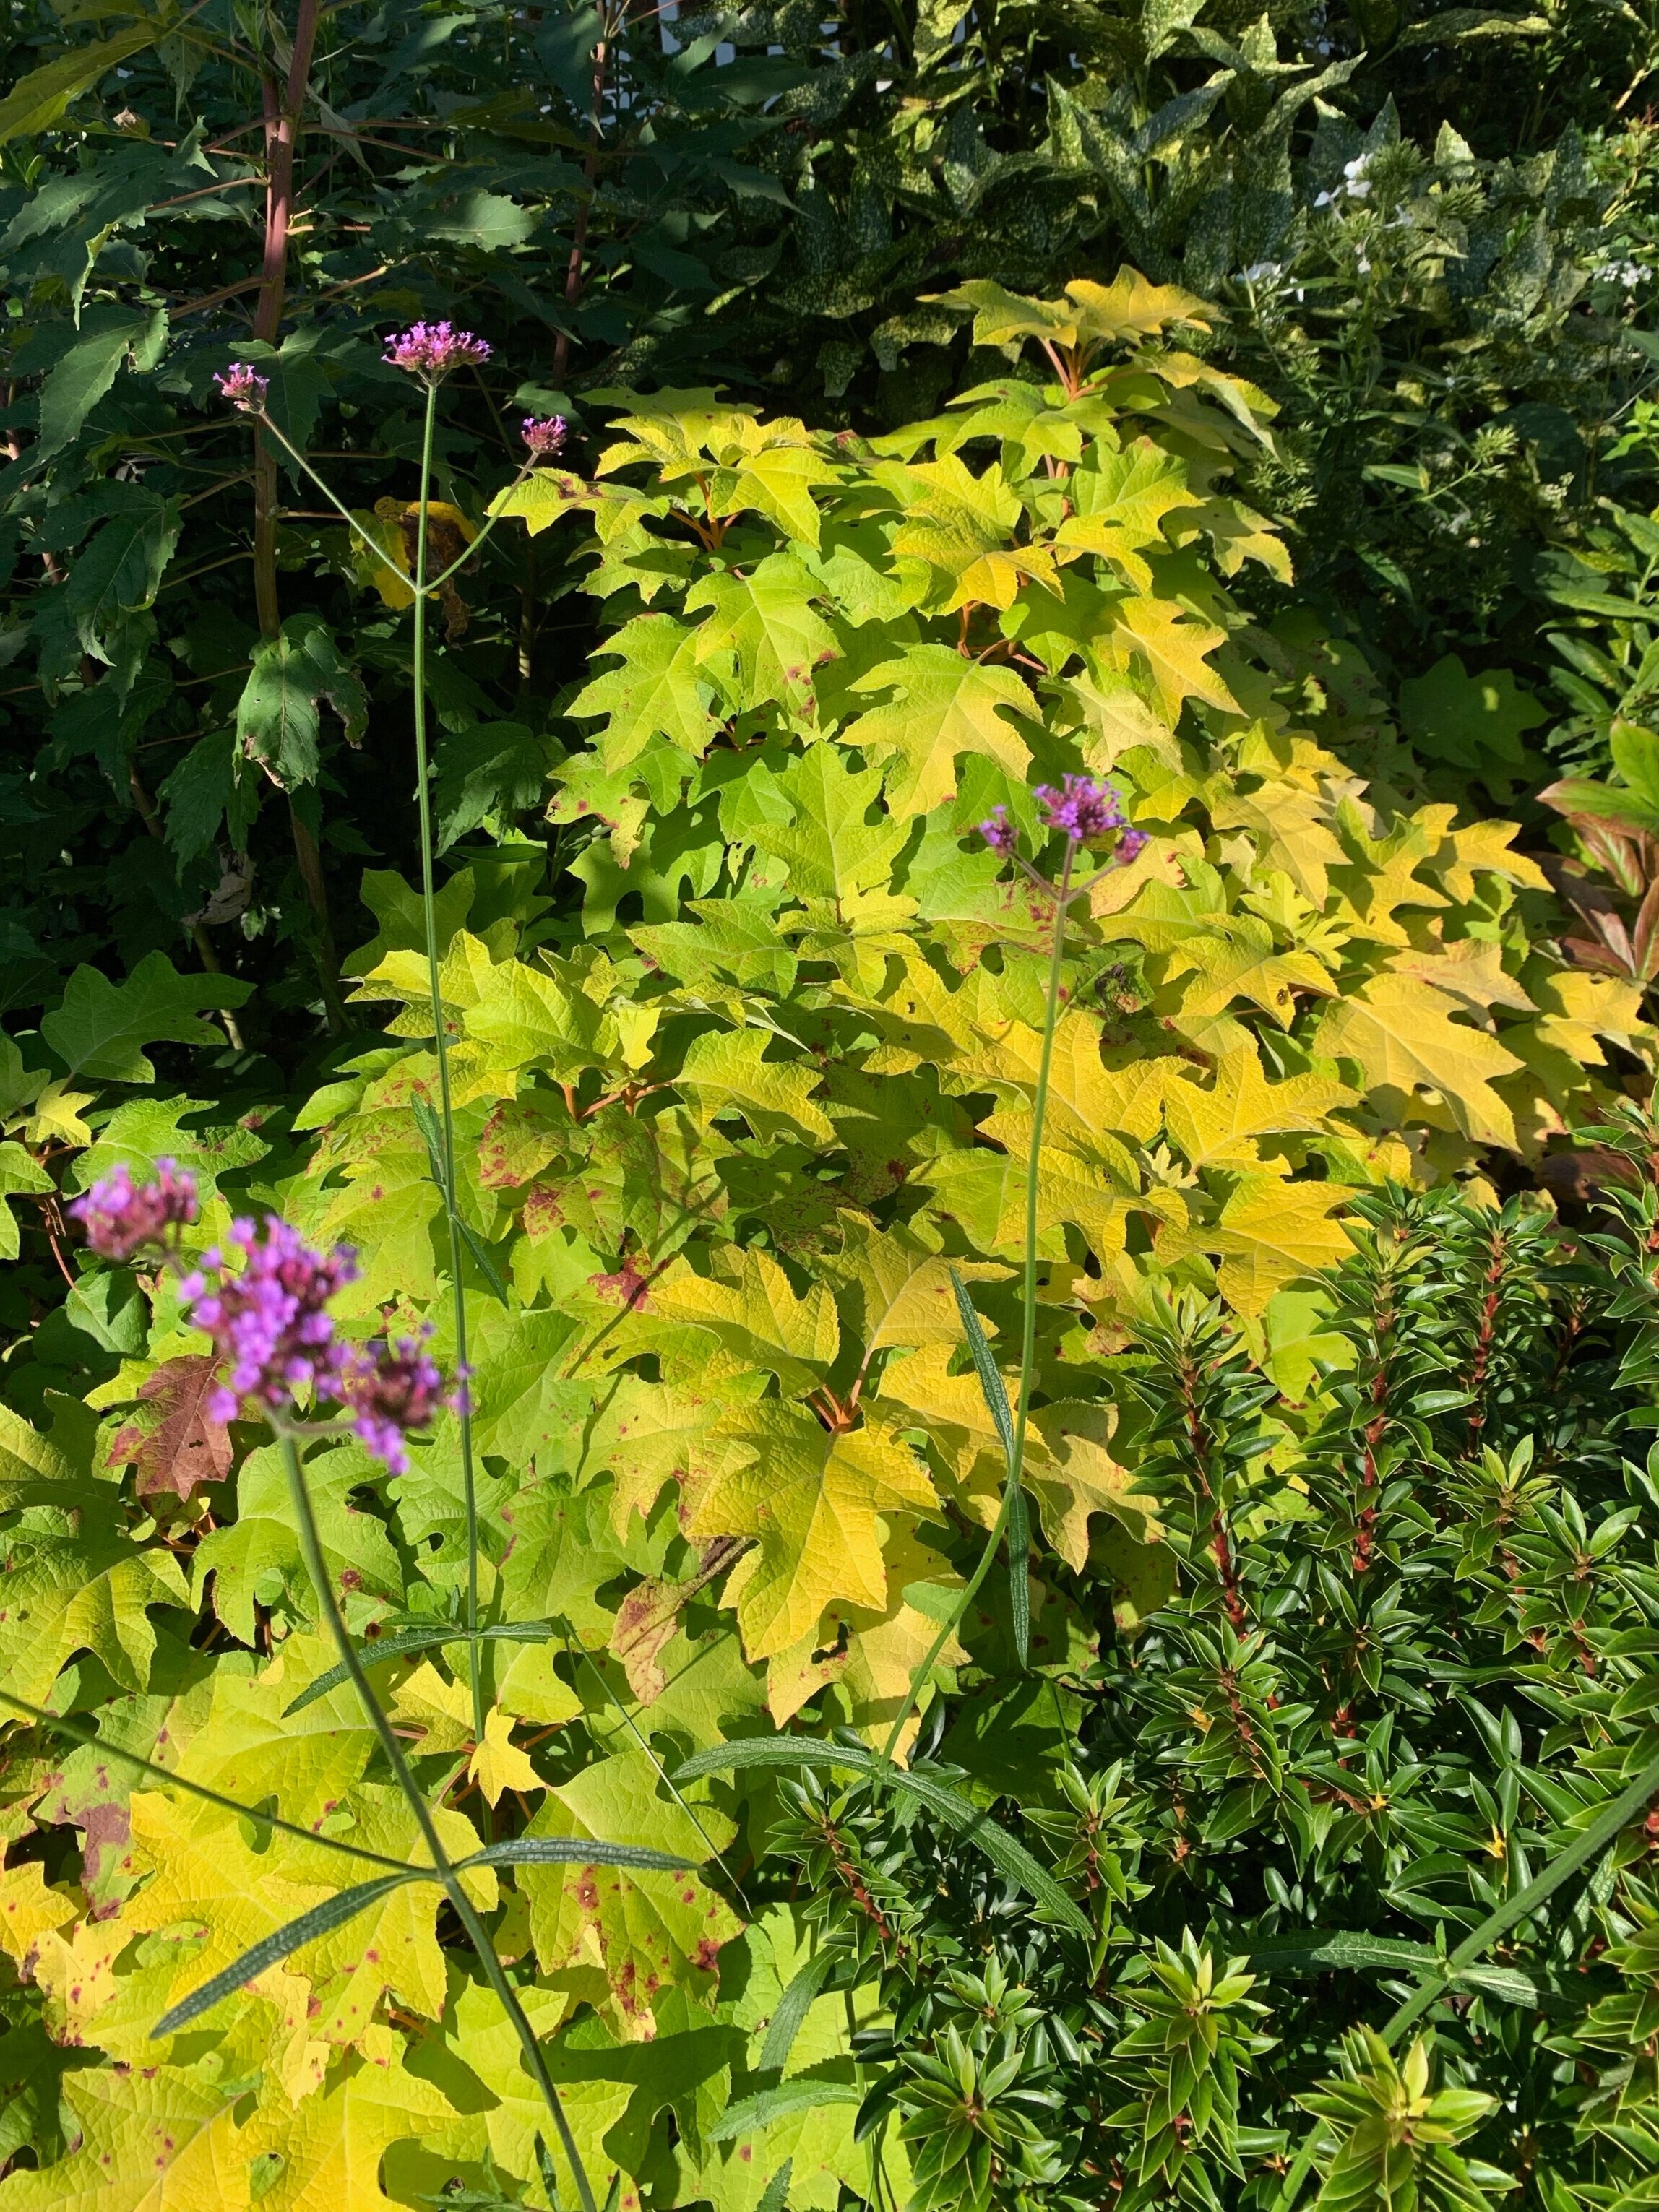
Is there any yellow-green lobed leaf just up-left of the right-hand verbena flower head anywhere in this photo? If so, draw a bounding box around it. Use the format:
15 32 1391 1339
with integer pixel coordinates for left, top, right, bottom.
840 646 1035 814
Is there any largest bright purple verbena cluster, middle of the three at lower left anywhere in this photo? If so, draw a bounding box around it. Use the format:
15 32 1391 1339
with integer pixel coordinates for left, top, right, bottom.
179 1214 358 1420
